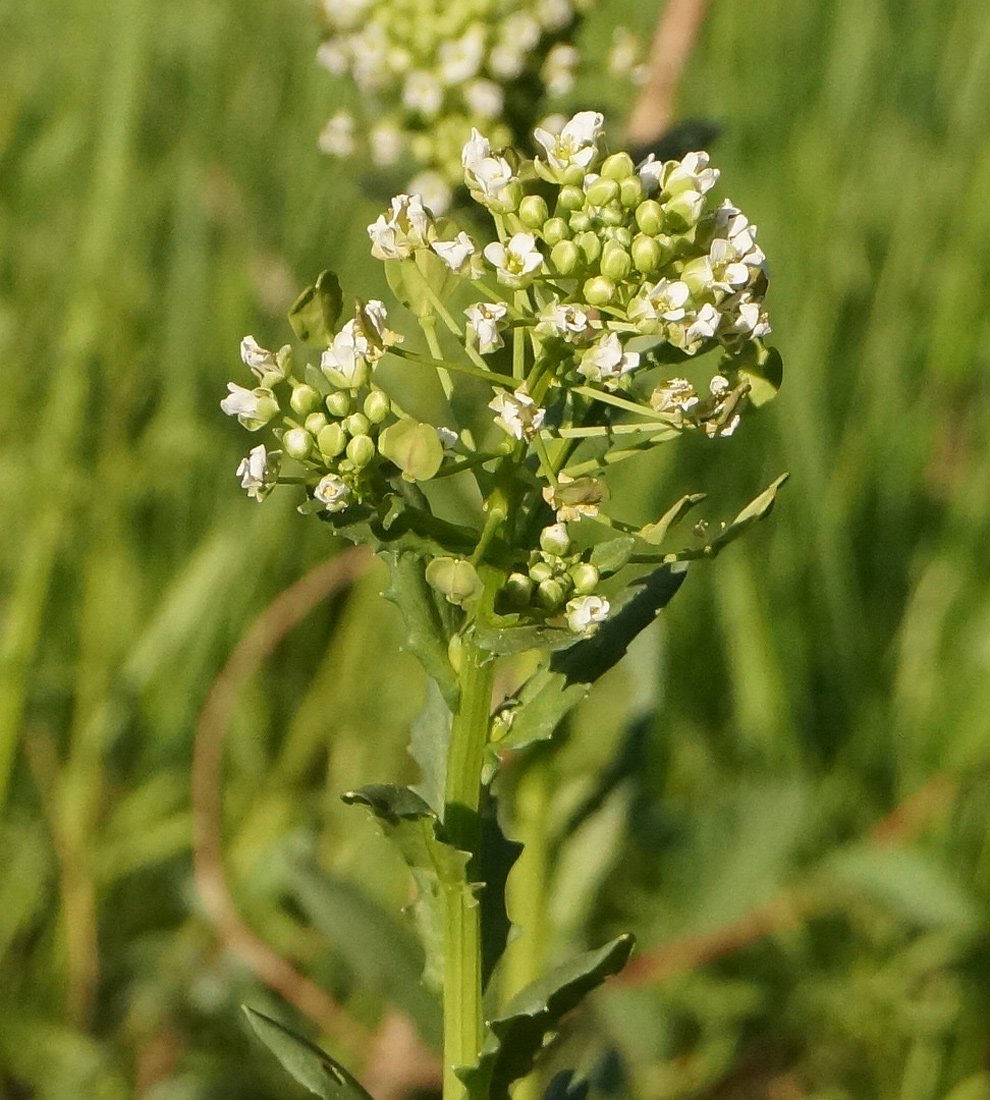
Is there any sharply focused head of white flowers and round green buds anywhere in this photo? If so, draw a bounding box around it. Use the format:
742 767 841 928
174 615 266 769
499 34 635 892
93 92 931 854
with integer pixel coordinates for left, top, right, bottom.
222 111 776 636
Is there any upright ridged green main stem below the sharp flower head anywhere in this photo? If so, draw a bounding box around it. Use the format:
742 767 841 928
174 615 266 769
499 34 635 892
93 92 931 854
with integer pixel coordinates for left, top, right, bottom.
443 639 494 1100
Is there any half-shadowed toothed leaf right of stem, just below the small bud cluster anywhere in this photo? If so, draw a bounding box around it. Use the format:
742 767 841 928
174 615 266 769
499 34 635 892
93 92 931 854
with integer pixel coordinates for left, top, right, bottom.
496 565 684 750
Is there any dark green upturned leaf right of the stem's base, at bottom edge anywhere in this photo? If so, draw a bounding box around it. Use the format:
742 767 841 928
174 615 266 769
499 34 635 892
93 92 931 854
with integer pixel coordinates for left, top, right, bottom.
458 935 635 1100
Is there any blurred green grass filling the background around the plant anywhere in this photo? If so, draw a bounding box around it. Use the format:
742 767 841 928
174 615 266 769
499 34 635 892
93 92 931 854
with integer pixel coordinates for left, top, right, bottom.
0 0 990 1100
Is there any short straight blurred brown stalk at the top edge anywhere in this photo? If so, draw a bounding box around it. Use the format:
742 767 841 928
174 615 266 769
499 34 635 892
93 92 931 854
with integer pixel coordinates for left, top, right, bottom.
626 0 711 145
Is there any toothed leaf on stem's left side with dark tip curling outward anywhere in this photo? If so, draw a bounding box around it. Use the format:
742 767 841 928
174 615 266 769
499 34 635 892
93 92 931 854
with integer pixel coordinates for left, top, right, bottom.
341 784 477 990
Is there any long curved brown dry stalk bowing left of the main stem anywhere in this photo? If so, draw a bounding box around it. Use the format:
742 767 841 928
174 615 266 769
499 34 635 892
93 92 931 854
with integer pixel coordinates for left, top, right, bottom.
191 548 372 1049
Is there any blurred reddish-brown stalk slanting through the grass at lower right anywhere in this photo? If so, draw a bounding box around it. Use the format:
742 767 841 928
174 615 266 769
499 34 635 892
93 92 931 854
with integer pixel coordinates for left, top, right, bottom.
616 774 958 986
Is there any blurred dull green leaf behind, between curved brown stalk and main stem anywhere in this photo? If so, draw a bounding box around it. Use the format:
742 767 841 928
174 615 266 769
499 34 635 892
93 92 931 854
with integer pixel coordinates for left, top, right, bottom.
289 862 442 1049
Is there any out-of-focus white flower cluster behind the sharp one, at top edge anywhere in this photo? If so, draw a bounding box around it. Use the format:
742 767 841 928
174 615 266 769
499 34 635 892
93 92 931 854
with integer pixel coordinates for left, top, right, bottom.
318 0 635 213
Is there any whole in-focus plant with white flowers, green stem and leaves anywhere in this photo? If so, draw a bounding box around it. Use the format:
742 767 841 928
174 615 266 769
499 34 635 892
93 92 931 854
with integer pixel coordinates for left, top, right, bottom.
222 111 783 1100
